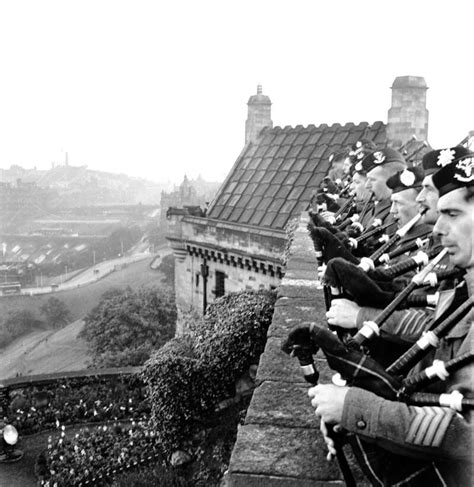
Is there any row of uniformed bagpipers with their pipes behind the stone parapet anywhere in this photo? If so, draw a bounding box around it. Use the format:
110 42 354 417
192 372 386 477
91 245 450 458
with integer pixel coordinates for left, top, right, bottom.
296 141 474 487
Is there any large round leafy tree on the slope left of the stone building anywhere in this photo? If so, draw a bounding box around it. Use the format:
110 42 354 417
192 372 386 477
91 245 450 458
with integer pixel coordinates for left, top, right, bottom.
80 287 176 367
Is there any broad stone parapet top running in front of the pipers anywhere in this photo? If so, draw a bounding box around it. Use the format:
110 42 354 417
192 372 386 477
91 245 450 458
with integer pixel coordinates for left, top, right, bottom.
226 213 368 487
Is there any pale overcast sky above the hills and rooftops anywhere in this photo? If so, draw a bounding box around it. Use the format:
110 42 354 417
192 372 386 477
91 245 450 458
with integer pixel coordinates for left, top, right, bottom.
0 0 474 182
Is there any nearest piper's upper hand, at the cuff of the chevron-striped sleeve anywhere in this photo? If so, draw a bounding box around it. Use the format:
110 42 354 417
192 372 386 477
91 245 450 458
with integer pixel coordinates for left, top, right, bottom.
308 384 349 424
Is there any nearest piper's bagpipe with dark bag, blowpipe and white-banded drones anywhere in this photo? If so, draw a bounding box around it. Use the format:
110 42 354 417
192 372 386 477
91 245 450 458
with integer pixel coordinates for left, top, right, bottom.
282 250 474 411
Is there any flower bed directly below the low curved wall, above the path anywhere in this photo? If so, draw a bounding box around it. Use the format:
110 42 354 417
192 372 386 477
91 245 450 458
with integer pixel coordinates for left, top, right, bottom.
7 375 150 435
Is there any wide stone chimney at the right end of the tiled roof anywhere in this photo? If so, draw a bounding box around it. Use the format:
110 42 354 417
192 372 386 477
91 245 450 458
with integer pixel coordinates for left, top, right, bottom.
387 76 428 147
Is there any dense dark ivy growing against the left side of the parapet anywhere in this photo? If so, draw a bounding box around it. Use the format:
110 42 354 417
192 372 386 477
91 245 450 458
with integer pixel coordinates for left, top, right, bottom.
142 291 276 453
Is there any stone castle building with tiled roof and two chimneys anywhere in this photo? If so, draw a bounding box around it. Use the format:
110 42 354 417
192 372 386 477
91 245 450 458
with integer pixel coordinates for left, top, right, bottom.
167 76 428 332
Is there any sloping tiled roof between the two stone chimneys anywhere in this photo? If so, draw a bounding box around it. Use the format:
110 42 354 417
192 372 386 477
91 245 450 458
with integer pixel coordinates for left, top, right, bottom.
207 122 387 230
